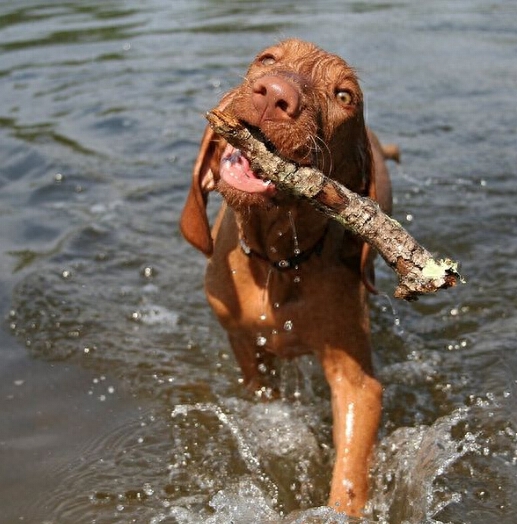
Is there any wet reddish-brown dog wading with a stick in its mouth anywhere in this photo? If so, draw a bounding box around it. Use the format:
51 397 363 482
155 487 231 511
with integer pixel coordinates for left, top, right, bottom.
181 40 391 515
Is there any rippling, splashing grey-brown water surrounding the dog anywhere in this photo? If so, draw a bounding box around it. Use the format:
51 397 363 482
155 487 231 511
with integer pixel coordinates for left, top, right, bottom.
0 0 517 524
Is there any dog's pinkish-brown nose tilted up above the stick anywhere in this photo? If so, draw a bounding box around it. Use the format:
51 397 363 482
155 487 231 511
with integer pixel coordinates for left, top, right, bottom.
252 75 301 121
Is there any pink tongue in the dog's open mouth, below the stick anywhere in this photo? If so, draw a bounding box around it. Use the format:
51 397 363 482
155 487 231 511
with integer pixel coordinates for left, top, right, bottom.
220 145 275 195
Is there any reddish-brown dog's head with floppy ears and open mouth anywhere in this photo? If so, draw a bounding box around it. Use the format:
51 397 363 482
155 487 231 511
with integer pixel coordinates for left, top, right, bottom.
181 39 372 255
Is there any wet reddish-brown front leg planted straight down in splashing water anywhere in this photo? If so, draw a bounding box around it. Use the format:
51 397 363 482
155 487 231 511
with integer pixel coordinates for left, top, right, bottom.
321 349 382 516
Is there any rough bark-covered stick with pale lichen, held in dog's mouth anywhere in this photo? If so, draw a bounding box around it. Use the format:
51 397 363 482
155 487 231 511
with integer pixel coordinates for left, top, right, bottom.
207 110 463 300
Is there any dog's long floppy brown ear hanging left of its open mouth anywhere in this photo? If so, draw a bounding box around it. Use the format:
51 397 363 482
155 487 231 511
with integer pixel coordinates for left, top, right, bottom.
180 91 233 257
